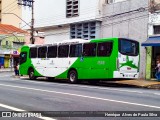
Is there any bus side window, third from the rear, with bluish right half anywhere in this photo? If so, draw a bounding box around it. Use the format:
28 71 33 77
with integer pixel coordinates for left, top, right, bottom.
69 44 82 57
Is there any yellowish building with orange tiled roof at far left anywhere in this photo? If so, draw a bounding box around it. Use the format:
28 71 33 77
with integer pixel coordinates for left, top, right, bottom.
0 24 28 68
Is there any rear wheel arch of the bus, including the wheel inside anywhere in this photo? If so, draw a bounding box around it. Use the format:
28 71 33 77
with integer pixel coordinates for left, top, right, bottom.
68 68 78 83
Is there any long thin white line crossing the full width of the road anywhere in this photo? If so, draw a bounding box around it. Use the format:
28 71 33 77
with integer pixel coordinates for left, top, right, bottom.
0 84 160 109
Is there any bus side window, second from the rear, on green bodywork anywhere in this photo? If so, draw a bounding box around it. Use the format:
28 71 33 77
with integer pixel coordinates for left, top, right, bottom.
83 43 96 56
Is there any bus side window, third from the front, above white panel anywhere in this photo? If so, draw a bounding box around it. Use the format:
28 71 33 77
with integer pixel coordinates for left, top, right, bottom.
47 46 57 58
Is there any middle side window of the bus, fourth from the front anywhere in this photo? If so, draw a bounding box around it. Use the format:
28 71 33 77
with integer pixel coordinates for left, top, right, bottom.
58 45 69 58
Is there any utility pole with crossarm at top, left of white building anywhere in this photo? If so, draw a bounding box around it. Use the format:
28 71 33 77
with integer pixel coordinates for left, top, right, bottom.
18 0 35 44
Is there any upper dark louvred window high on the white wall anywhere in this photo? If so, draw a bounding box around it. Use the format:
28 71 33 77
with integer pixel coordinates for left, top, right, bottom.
66 0 79 17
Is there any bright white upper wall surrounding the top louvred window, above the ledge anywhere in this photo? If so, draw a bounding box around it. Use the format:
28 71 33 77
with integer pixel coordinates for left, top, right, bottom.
22 0 104 27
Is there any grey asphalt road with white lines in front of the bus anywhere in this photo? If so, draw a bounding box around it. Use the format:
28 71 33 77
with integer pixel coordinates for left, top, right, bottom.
0 72 160 120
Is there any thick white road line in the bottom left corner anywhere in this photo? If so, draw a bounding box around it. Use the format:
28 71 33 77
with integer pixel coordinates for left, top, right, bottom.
0 103 56 120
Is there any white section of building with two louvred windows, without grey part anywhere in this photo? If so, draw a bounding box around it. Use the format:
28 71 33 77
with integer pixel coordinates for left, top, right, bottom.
30 0 102 44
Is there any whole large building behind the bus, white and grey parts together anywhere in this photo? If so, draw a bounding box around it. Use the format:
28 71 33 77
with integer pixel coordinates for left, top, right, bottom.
21 0 156 78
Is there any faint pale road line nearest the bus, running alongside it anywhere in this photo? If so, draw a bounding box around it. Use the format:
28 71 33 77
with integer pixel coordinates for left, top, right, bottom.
15 78 143 94
